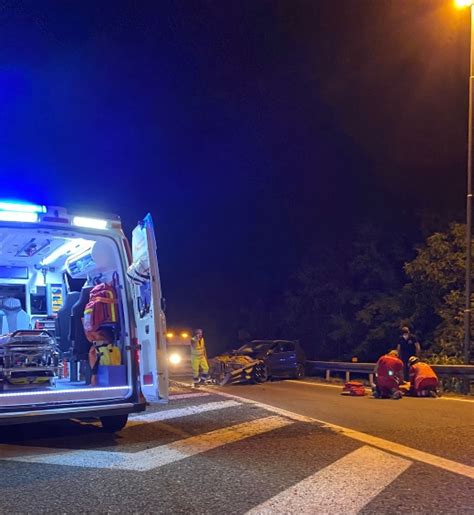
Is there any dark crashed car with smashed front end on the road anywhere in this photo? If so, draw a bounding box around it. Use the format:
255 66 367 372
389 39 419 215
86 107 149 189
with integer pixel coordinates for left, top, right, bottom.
210 340 306 385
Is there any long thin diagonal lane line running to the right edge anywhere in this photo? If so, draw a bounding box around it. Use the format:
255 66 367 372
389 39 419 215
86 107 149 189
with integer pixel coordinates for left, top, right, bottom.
202 391 474 479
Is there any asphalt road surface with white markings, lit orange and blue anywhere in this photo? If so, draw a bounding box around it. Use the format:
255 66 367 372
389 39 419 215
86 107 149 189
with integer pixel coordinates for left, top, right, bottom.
0 381 474 514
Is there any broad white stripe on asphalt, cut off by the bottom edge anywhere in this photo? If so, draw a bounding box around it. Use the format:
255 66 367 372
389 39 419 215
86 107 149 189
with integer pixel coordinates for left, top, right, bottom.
247 446 412 515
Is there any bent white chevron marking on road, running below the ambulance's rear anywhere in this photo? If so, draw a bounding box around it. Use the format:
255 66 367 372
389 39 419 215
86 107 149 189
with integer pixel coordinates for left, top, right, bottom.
0 416 292 472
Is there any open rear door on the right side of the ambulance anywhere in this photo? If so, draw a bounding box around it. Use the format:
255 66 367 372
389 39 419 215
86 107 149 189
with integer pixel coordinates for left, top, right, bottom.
128 214 168 402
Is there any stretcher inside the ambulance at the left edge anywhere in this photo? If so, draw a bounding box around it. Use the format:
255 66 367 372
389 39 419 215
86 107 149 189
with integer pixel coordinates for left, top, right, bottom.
0 330 60 388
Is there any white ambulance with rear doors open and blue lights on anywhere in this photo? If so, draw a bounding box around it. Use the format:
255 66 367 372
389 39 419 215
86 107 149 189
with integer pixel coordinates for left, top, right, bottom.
0 200 168 431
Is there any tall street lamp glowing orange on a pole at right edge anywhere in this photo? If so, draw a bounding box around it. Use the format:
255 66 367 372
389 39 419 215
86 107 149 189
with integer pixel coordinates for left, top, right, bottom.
454 0 474 364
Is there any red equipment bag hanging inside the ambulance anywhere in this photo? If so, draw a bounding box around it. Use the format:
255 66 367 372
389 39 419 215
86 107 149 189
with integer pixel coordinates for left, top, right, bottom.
82 283 118 343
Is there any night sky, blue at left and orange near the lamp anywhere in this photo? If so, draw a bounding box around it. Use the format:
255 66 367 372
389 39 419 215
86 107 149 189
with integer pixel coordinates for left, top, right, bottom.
0 0 469 349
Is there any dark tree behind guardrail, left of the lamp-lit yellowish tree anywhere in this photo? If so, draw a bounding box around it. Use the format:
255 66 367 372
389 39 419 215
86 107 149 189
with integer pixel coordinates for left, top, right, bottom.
286 222 410 359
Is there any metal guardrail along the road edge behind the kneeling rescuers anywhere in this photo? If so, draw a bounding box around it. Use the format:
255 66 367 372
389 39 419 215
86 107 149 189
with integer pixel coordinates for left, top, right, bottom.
306 361 474 383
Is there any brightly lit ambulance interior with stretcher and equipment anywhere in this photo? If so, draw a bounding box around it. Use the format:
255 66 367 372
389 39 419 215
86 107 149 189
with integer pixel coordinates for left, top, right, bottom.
0 227 131 407
